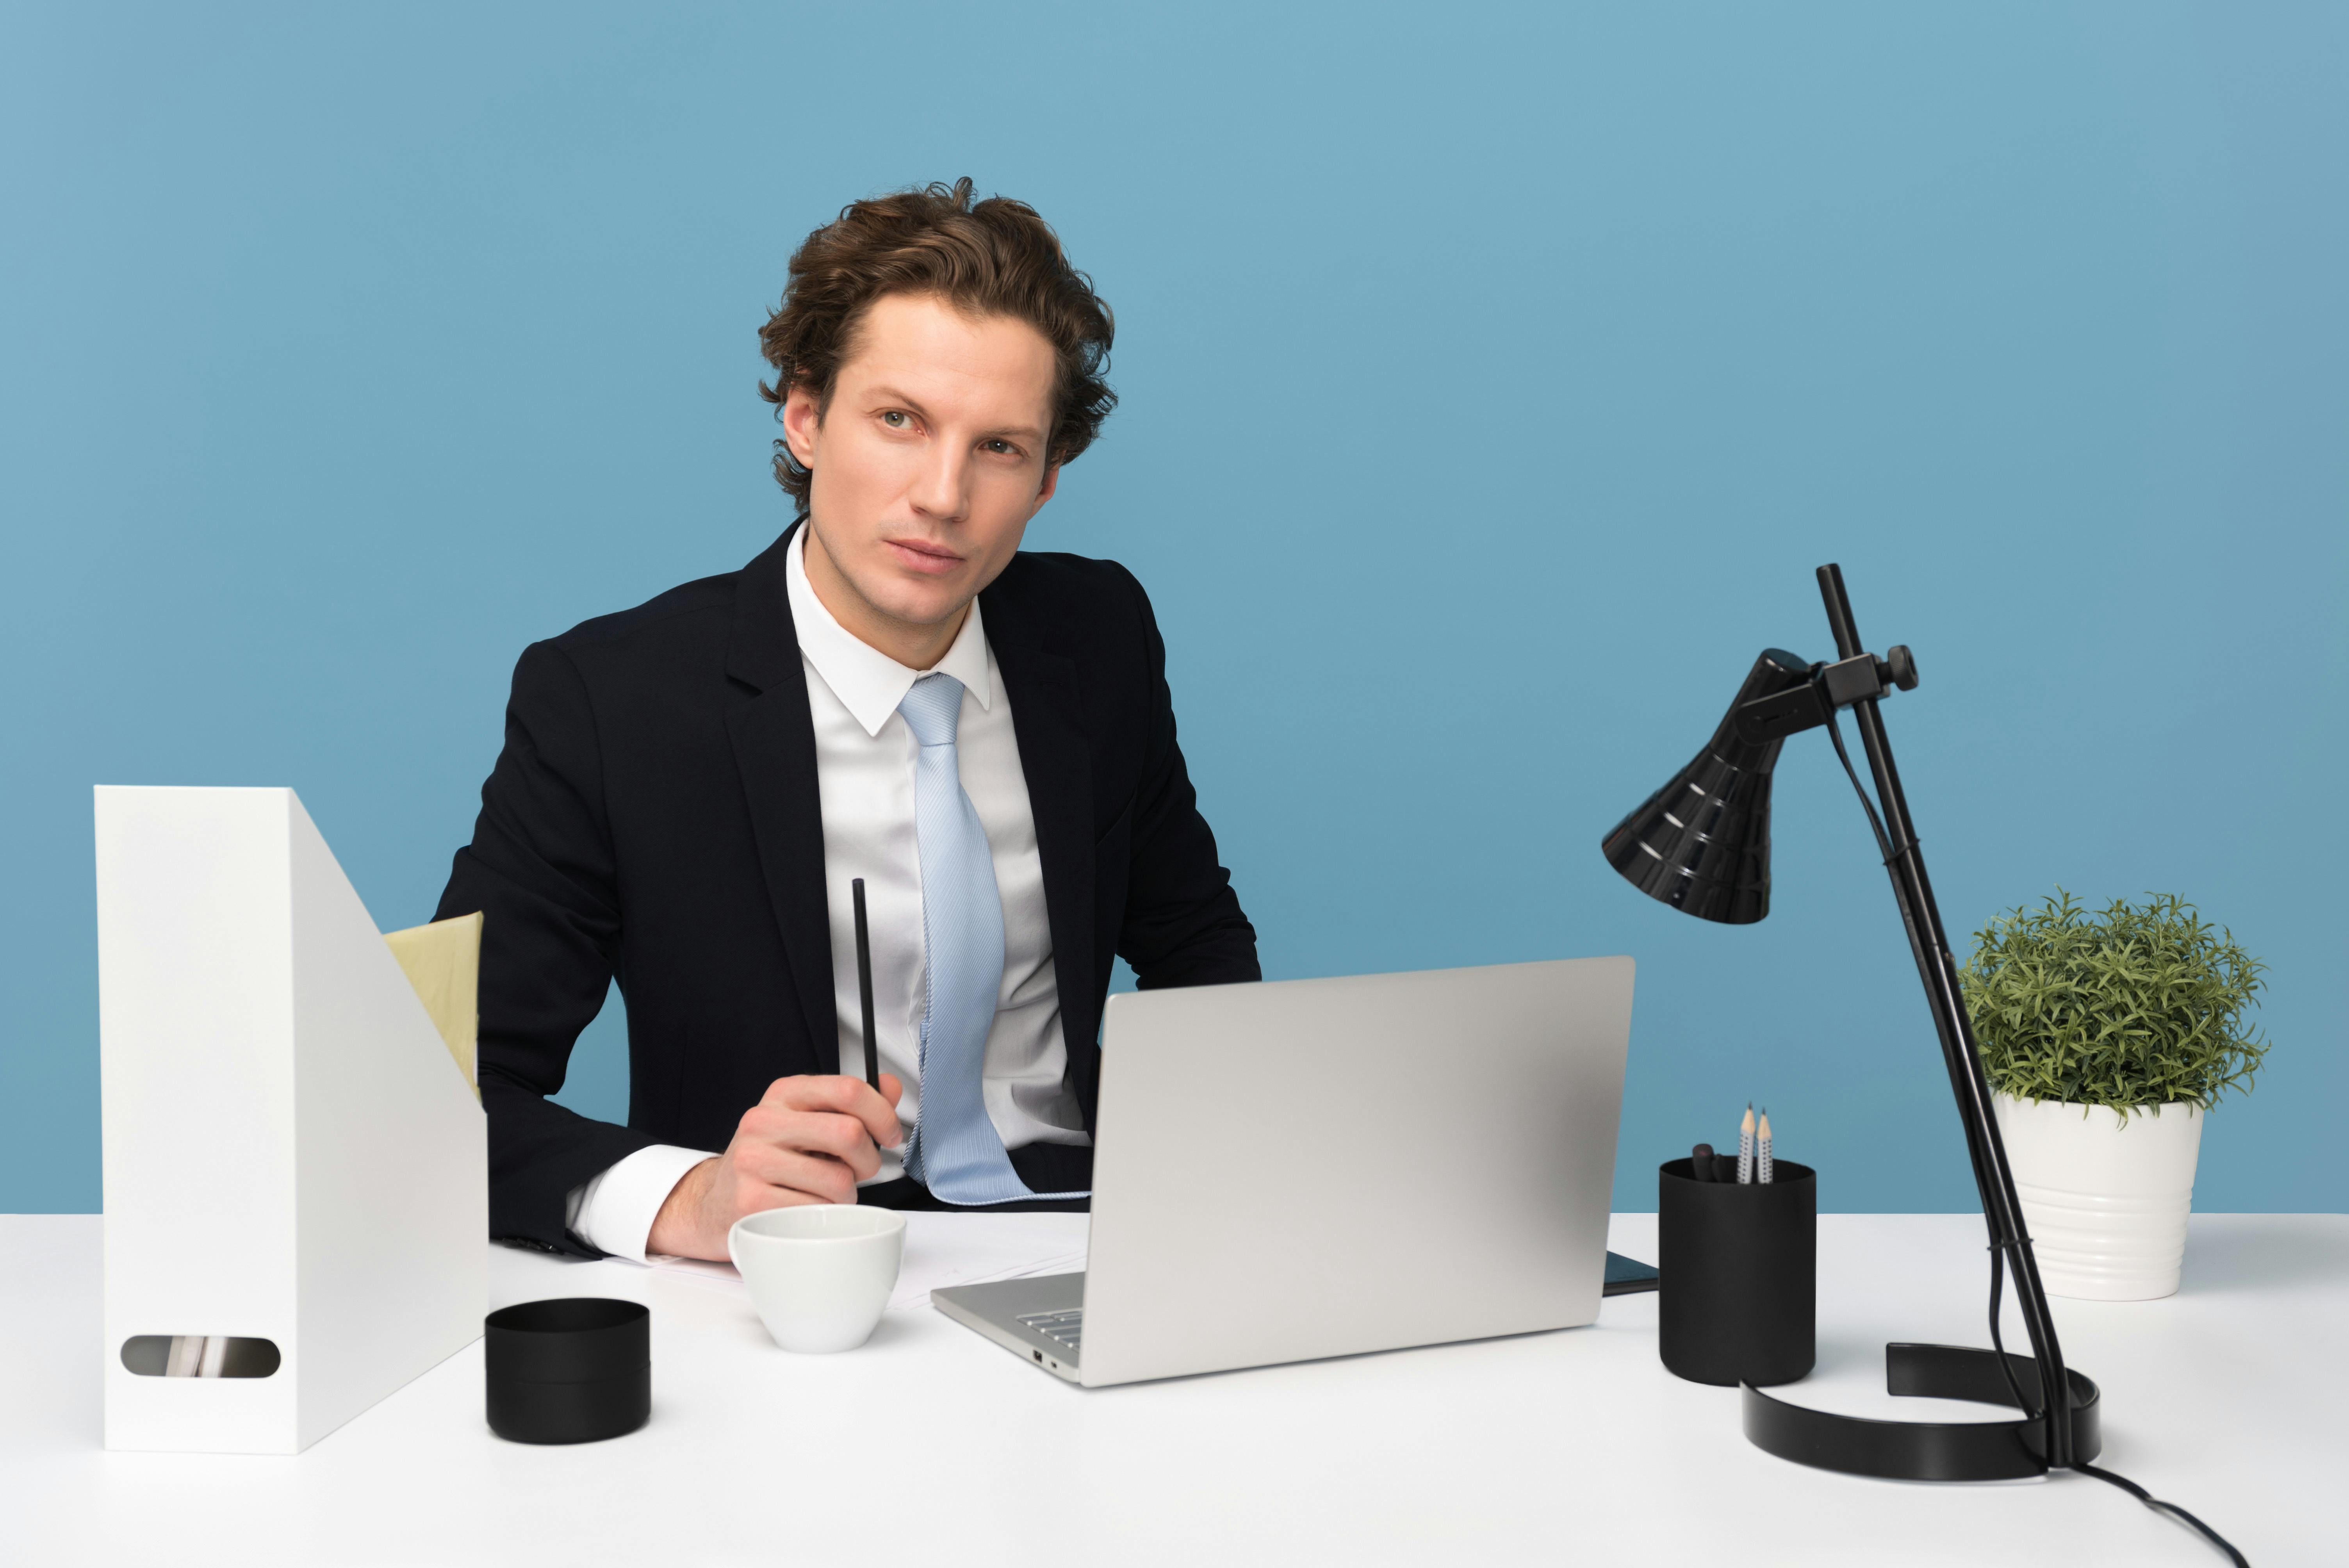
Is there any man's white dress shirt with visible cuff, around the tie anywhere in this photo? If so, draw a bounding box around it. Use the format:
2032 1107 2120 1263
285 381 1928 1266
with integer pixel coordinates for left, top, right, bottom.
566 528 1090 1260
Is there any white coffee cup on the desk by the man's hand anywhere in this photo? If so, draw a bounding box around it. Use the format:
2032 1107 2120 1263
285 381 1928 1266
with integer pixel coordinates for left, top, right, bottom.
726 1204 904 1352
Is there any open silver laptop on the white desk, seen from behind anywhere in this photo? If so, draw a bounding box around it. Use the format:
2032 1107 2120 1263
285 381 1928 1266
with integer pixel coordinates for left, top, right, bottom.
930 958 1633 1387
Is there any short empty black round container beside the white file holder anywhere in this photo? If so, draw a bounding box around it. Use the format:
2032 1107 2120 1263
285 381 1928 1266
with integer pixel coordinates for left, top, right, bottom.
481 1296 653 1443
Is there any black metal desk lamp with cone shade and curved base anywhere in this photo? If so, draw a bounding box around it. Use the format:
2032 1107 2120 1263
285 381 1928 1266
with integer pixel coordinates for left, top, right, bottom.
1604 566 2105 1483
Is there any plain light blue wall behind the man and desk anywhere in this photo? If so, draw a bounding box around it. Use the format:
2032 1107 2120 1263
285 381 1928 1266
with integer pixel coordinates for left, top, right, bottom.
0 0 2349 1211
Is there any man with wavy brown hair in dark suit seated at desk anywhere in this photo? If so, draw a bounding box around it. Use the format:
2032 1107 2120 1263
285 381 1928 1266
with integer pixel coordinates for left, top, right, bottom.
439 178 1259 1258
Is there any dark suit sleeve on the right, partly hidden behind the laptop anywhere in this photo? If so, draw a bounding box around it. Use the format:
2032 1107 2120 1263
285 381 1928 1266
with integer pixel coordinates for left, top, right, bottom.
1118 568 1264 991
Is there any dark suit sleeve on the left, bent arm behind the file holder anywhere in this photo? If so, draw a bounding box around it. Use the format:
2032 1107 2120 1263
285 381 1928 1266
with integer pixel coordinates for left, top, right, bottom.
435 643 655 1258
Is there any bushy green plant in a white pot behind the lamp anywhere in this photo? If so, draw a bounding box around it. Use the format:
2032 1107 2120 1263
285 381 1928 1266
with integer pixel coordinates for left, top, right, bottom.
1959 887 2267 1301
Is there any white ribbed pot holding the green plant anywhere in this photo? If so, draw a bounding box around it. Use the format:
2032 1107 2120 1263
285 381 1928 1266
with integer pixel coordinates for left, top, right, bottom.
1992 1094 2203 1301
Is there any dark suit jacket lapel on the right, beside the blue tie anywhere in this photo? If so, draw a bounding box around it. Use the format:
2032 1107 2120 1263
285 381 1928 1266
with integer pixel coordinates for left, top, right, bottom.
980 561 1097 1063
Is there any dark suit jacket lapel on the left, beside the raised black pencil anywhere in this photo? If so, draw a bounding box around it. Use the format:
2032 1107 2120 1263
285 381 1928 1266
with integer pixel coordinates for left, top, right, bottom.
726 524 850 1073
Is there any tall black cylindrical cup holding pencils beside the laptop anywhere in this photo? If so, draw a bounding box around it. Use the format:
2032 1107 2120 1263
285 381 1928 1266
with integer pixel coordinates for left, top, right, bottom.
1656 1160 1818 1387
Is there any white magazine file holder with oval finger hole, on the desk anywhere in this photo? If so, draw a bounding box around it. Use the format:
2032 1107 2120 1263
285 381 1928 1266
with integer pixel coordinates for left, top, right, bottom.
96 786 488 1453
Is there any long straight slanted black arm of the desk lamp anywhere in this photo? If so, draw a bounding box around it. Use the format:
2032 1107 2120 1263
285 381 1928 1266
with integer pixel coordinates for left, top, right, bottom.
1804 563 2074 1469
